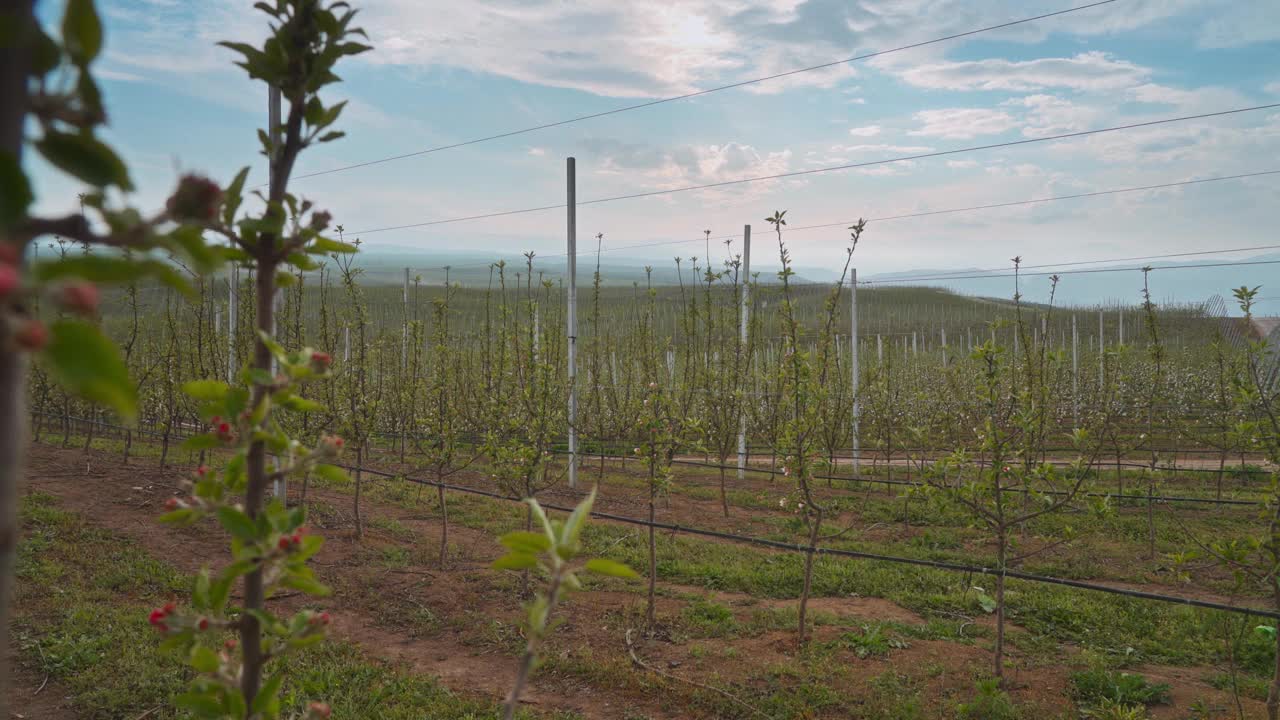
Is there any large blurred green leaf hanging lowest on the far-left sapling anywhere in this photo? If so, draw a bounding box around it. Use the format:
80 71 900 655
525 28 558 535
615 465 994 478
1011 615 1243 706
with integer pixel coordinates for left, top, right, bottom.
44 320 138 423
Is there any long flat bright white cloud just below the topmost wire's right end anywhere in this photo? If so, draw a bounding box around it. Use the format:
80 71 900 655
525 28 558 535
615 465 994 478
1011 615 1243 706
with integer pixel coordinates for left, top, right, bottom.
900 51 1151 91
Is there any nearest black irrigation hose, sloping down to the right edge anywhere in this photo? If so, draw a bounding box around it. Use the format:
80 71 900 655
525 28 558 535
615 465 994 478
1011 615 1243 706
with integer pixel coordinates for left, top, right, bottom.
340 465 1280 620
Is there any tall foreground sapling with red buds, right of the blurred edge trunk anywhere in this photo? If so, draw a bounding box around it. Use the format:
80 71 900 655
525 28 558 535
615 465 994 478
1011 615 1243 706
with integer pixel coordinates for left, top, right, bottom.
152 0 369 719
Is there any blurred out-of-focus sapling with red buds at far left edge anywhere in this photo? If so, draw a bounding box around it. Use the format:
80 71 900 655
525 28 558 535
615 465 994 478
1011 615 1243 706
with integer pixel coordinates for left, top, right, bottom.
0 0 280 717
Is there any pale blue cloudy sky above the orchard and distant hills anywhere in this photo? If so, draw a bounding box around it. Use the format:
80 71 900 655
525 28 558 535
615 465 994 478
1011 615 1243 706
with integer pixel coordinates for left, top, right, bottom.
24 0 1280 293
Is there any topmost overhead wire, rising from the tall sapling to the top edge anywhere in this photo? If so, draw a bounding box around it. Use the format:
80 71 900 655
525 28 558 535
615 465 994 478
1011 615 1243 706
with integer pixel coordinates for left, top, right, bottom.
293 0 1117 179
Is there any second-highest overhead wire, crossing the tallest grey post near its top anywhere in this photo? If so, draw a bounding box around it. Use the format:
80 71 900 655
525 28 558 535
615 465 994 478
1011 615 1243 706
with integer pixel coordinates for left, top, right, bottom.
352 102 1280 234
